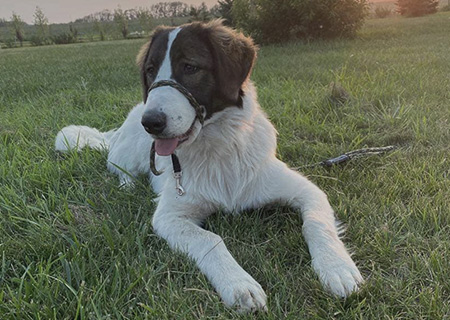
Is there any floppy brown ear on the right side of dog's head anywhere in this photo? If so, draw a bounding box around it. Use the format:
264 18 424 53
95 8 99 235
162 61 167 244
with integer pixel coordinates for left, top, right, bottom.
207 20 257 104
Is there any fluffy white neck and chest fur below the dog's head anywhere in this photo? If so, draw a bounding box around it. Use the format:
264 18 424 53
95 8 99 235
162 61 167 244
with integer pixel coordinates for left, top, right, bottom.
158 82 276 208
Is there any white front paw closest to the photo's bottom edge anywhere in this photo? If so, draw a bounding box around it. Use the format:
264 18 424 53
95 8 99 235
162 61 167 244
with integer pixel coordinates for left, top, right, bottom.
218 275 267 312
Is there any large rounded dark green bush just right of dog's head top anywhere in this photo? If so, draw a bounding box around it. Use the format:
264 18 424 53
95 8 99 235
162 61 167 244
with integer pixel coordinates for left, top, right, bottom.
232 0 368 43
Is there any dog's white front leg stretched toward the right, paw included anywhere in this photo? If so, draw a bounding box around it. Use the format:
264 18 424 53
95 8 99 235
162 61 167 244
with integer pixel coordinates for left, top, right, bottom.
259 160 363 297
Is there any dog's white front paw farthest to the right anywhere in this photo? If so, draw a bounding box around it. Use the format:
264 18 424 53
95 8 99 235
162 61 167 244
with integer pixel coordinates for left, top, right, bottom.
313 257 364 298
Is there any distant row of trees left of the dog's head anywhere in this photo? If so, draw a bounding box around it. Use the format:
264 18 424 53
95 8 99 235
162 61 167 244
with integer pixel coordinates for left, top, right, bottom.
0 1 219 47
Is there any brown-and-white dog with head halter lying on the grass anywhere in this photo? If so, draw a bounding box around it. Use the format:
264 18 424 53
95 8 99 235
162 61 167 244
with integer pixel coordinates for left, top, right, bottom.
55 20 363 311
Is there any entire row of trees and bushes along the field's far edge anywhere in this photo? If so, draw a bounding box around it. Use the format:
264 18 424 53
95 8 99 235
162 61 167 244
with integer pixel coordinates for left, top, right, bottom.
0 0 446 47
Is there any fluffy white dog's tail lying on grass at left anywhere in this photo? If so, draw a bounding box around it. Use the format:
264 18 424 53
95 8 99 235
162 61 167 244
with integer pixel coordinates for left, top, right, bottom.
55 125 116 151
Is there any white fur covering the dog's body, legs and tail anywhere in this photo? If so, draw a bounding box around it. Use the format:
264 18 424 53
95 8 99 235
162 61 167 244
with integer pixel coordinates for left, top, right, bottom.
55 27 363 311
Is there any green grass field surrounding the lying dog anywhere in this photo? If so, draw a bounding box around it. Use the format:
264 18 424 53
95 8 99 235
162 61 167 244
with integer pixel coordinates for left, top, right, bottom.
0 13 450 320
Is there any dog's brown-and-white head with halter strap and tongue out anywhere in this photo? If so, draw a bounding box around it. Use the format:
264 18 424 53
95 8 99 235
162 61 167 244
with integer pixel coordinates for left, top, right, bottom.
137 20 256 155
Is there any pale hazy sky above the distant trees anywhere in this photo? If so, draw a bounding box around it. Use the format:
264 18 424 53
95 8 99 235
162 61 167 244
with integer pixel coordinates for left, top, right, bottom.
0 0 217 23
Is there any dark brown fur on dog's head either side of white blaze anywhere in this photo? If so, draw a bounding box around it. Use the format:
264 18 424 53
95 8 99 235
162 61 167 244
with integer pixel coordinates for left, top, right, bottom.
136 20 257 118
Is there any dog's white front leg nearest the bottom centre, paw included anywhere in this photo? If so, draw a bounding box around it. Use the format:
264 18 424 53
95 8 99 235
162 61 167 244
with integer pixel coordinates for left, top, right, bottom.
153 200 267 312
